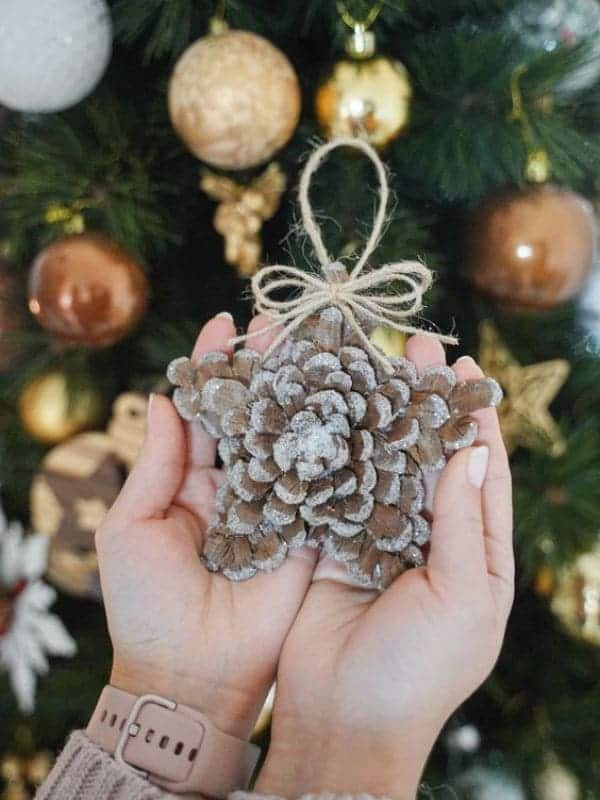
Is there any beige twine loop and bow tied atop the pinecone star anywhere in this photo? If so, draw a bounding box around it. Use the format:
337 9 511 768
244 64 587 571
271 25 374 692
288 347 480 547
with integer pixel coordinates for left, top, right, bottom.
230 137 457 372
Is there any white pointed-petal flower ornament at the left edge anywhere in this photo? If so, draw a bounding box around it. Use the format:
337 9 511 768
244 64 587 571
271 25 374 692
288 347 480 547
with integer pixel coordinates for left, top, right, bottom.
0 500 76 714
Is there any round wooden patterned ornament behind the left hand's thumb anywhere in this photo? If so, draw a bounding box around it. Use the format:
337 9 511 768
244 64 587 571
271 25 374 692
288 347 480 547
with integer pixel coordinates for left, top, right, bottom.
30 392 147 599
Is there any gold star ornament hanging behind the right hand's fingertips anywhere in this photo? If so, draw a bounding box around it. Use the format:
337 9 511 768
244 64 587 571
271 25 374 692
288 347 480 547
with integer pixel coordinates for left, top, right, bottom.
479 322 571 457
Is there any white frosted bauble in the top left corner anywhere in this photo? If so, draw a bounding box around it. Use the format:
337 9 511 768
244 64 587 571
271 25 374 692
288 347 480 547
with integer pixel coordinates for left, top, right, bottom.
0 0 112 112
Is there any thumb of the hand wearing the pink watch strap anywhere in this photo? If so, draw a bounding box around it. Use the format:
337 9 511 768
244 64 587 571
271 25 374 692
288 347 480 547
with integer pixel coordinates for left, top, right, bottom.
113 394 186 520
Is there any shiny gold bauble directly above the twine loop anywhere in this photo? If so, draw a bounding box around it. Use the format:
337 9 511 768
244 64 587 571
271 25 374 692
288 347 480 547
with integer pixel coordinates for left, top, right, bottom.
315 56 412 147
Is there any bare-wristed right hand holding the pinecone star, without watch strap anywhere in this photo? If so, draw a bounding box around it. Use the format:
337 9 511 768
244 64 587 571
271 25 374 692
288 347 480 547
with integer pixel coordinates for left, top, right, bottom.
256 336 514 800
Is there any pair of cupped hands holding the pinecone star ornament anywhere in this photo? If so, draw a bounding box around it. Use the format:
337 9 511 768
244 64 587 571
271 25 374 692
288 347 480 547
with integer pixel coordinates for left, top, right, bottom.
96 314 514 800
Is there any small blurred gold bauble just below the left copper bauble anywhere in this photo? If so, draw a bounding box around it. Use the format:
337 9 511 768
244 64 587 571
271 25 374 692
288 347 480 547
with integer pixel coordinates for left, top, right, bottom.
19 371 104 444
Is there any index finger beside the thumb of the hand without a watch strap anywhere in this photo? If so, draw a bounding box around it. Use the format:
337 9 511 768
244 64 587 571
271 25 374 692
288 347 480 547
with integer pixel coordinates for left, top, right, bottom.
453 356 515 605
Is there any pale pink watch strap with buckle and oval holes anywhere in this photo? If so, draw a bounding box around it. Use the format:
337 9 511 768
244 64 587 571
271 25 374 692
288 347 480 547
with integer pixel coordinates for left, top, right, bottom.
87 686 260 800
